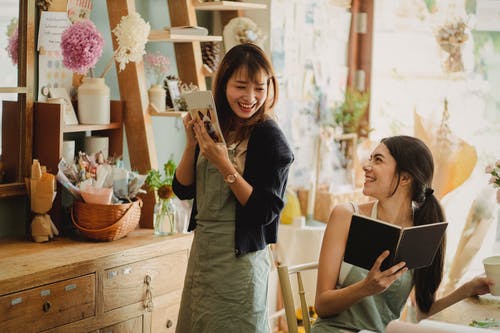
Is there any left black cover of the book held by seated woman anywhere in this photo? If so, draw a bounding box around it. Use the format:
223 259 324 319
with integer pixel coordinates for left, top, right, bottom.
344 214 401 271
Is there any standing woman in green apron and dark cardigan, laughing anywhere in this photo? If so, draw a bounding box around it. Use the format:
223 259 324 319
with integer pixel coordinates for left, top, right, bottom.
173 44 293 333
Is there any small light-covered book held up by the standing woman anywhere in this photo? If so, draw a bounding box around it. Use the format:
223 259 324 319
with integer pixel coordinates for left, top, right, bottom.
181 90 226 145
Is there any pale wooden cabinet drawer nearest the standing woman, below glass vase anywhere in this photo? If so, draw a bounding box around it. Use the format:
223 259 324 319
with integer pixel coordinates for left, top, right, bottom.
103 250 188 311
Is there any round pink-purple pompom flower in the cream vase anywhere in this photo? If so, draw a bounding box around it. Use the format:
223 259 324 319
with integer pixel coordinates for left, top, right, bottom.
61 20 104 74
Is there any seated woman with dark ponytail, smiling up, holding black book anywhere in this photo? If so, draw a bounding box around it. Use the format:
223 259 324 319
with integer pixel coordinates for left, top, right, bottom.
312 136 492 333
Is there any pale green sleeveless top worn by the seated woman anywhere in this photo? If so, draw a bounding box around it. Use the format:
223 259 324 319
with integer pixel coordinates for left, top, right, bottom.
312 202 413 333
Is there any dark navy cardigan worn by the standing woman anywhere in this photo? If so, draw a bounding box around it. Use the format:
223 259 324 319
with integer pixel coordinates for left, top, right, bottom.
173 119 294 255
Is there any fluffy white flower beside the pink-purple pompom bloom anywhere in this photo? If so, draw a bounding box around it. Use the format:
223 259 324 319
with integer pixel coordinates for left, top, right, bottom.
113 12 147 71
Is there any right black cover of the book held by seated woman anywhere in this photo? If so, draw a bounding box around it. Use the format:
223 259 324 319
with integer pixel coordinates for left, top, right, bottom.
394 222 448 269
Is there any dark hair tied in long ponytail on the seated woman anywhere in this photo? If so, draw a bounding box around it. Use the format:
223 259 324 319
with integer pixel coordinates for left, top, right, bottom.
381 135 446 312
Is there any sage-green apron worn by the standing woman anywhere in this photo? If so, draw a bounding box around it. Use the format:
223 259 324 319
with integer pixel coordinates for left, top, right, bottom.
176 144 271 333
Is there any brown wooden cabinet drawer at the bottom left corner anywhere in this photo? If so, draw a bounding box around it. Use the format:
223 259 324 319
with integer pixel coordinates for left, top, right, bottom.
0 274 95 332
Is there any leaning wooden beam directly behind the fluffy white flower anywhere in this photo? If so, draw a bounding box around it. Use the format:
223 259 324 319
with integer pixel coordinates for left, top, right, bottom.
107 0 158 228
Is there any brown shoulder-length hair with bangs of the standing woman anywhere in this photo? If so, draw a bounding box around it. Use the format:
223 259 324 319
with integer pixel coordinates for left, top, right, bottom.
213 43 278 139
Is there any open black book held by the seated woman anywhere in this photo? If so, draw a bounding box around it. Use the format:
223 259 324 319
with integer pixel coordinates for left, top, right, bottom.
344 214 448 271
